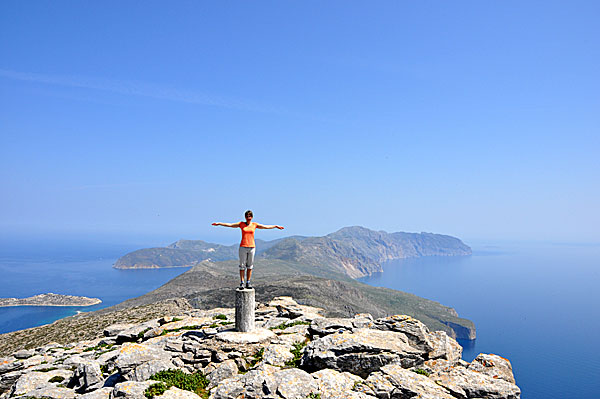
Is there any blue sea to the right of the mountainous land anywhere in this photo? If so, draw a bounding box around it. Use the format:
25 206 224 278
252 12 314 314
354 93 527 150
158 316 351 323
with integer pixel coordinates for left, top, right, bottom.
361 243 600 399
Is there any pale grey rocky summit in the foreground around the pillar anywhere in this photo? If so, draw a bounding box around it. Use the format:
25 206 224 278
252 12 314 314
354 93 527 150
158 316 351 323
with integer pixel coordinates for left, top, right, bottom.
0 297 521 399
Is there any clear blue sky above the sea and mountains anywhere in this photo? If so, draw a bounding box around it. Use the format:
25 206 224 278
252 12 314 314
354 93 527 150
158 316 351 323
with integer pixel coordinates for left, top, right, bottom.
0 0 600 242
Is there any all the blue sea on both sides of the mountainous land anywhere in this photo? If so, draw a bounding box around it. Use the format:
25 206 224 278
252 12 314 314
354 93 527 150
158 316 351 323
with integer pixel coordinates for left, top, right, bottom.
0 236 600 399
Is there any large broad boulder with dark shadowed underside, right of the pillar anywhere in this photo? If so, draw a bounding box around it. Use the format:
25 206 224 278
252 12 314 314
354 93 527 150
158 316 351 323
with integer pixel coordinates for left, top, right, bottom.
300 328 424 378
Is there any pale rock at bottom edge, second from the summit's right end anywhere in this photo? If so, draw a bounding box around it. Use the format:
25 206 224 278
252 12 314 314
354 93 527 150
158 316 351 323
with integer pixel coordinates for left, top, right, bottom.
365 365 454 399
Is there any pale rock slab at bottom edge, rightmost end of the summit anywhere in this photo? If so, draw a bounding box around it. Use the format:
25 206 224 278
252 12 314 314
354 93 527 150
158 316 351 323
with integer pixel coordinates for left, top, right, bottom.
430 367 521 399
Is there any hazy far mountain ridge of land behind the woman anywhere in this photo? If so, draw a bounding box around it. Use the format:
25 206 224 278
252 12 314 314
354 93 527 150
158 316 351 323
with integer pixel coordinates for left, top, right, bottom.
114 226 472 278
